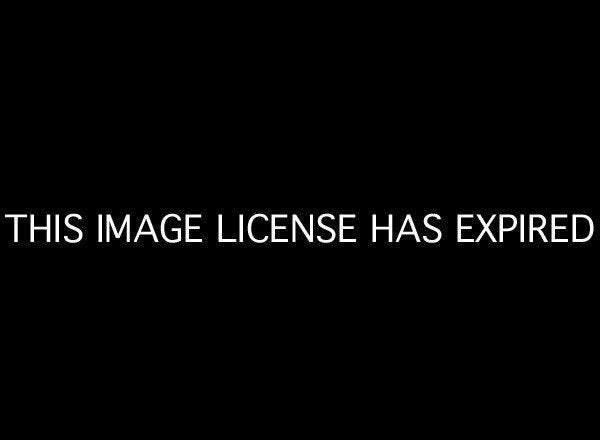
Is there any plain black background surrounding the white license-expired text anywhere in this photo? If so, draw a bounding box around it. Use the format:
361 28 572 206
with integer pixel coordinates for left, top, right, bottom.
1 5 598 433
